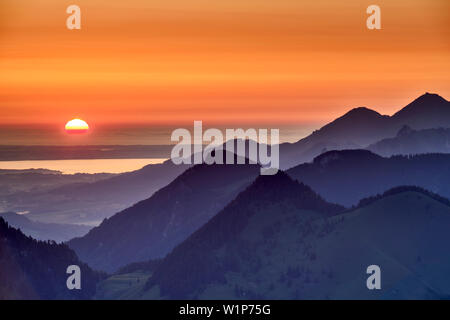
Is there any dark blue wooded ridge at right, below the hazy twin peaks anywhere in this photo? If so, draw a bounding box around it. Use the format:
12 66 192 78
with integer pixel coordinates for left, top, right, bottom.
287 149 450 207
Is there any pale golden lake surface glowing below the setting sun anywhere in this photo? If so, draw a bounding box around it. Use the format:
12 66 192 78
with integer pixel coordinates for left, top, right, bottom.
0 158 167 174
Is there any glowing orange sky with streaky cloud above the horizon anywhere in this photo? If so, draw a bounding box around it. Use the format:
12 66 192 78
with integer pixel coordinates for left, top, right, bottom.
0 0 450 124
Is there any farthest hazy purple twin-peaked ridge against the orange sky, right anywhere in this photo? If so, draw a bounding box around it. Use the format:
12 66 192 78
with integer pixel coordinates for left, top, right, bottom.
280 93 450 170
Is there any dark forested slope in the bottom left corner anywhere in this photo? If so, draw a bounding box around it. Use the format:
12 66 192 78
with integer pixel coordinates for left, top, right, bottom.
0 218 104 299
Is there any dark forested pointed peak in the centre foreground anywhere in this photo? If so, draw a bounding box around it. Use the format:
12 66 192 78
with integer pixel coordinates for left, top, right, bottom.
145 171 345 299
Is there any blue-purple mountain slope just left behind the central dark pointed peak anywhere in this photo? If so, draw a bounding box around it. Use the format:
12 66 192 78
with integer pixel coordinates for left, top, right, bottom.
68 164 259 272
